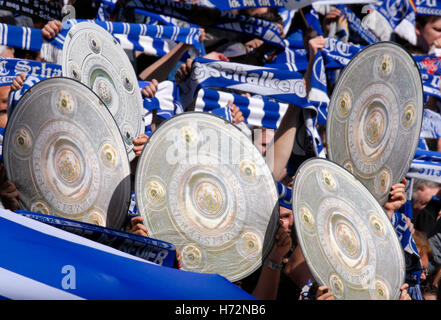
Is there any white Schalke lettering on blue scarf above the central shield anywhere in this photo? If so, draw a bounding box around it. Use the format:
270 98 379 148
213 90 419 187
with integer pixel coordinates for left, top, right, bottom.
191 62 306 98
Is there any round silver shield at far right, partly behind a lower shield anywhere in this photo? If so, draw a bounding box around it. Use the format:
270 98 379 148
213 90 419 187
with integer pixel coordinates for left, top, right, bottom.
326 42 423 205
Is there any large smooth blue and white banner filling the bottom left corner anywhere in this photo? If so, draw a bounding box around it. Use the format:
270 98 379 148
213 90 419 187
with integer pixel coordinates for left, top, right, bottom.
0 209 255 300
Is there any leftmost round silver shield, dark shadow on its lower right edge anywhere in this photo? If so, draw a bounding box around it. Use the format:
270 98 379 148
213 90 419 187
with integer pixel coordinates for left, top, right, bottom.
3 78 131 228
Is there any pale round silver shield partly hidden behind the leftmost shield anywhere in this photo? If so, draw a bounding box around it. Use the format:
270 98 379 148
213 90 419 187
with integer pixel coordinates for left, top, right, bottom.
62 22 145 161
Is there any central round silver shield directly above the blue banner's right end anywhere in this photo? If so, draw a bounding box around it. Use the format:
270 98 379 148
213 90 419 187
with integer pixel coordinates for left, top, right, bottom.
135 112 279 281
